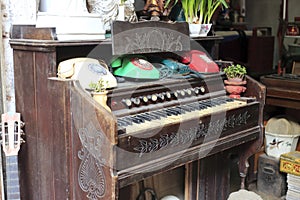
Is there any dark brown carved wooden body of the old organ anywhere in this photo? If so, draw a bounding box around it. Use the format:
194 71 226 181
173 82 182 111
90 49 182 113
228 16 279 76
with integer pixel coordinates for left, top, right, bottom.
11 22 265 200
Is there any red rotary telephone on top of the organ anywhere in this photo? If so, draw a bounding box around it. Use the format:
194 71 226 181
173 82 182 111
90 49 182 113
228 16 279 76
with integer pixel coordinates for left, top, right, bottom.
182 50 220 73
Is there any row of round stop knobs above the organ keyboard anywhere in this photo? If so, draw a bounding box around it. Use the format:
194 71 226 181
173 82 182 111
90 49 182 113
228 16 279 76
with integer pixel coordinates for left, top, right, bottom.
122 86 205 107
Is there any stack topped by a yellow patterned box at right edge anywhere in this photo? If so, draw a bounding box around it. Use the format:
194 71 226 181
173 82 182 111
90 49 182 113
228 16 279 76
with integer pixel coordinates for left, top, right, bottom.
280 151 300 200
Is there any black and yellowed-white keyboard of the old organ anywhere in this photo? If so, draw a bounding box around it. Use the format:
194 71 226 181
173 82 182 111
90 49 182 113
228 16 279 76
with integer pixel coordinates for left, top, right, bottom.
117 96 247 134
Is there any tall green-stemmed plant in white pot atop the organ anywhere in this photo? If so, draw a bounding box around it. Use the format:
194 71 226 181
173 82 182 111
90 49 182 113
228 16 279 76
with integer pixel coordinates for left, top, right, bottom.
165 0 228 36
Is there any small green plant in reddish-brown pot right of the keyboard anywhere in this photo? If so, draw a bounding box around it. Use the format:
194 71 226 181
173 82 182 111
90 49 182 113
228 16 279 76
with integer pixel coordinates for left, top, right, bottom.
223 64 247 98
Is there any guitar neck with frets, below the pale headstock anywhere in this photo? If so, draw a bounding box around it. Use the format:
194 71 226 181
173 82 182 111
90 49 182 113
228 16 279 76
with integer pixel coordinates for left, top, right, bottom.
5 155 21 200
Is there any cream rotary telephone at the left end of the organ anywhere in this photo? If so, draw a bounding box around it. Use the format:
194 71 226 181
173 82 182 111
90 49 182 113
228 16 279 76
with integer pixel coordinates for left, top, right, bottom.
57 57 117 89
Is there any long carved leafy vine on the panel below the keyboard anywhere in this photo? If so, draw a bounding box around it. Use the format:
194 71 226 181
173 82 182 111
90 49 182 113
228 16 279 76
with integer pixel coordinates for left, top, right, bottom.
134 111 251 157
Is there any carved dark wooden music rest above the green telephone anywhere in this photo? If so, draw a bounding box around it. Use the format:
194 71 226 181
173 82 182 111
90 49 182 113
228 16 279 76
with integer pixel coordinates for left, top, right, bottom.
112 21 191 55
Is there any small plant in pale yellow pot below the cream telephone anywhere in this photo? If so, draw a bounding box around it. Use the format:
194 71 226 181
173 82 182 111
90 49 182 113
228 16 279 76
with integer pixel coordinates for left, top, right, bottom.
89 78 111 112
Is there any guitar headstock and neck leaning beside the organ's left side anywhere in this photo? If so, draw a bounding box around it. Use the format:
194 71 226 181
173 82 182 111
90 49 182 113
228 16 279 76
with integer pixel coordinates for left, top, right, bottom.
1 113 24 200
